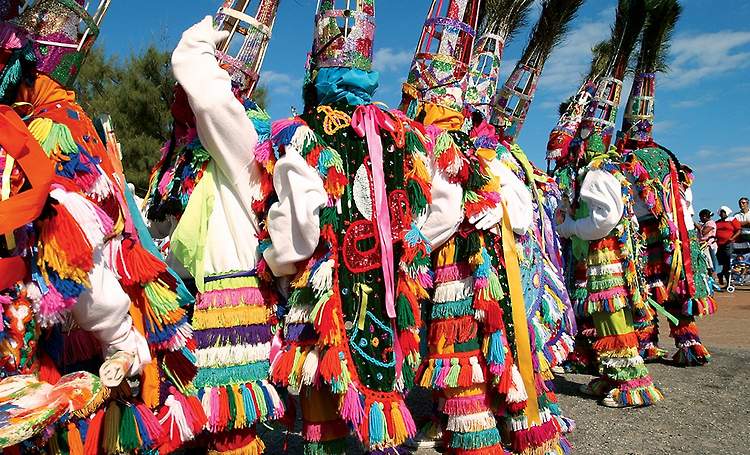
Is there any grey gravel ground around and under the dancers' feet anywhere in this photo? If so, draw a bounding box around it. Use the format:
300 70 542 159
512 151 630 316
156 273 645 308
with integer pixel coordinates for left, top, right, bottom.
261 290 750 455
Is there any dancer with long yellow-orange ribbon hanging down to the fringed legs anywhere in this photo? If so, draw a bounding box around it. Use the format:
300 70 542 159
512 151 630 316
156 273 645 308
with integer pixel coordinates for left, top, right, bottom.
402 2 559 453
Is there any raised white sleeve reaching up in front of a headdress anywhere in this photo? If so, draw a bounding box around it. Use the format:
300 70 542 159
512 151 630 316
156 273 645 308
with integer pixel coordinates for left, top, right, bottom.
172 16 259 206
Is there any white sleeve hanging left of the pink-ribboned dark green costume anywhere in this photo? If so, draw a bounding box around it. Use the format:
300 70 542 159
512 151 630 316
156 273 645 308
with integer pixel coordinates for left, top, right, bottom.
263 137 328 276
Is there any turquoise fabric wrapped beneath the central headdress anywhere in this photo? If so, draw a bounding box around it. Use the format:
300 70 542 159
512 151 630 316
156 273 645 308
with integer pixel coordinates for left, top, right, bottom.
315 67 380 106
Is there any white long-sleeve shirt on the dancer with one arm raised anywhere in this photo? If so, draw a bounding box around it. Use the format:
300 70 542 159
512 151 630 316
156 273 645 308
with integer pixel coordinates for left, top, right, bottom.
169 17 260 274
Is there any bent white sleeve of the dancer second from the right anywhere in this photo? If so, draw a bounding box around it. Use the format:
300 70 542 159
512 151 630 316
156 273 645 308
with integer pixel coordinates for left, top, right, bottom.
558 169 624 240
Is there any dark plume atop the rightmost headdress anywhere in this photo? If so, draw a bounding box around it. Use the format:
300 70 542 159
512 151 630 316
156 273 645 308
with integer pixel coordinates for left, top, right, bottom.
638 0 682 72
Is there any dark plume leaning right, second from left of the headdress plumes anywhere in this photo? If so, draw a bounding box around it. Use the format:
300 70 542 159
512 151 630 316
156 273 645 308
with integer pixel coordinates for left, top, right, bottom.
520 0 584 67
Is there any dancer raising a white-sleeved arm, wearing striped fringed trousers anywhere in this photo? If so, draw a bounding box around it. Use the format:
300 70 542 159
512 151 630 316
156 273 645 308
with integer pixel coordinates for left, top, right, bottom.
146 1 284 455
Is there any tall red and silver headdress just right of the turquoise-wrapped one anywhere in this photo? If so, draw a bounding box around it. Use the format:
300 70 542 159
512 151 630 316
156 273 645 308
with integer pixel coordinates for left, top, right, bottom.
401 0 480 112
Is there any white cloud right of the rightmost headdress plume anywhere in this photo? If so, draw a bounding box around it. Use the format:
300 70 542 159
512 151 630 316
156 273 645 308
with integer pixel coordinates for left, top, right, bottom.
664 30 750 88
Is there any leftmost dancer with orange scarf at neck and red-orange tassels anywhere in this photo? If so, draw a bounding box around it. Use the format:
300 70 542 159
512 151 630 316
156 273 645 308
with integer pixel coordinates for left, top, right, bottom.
1 0 203 453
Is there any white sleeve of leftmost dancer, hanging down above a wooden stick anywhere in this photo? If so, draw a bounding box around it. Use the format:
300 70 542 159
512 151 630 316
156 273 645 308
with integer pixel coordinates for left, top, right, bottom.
72 247 151 375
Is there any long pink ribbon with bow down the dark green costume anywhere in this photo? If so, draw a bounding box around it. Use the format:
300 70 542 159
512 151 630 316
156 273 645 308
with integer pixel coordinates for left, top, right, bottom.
352 104 396 319
